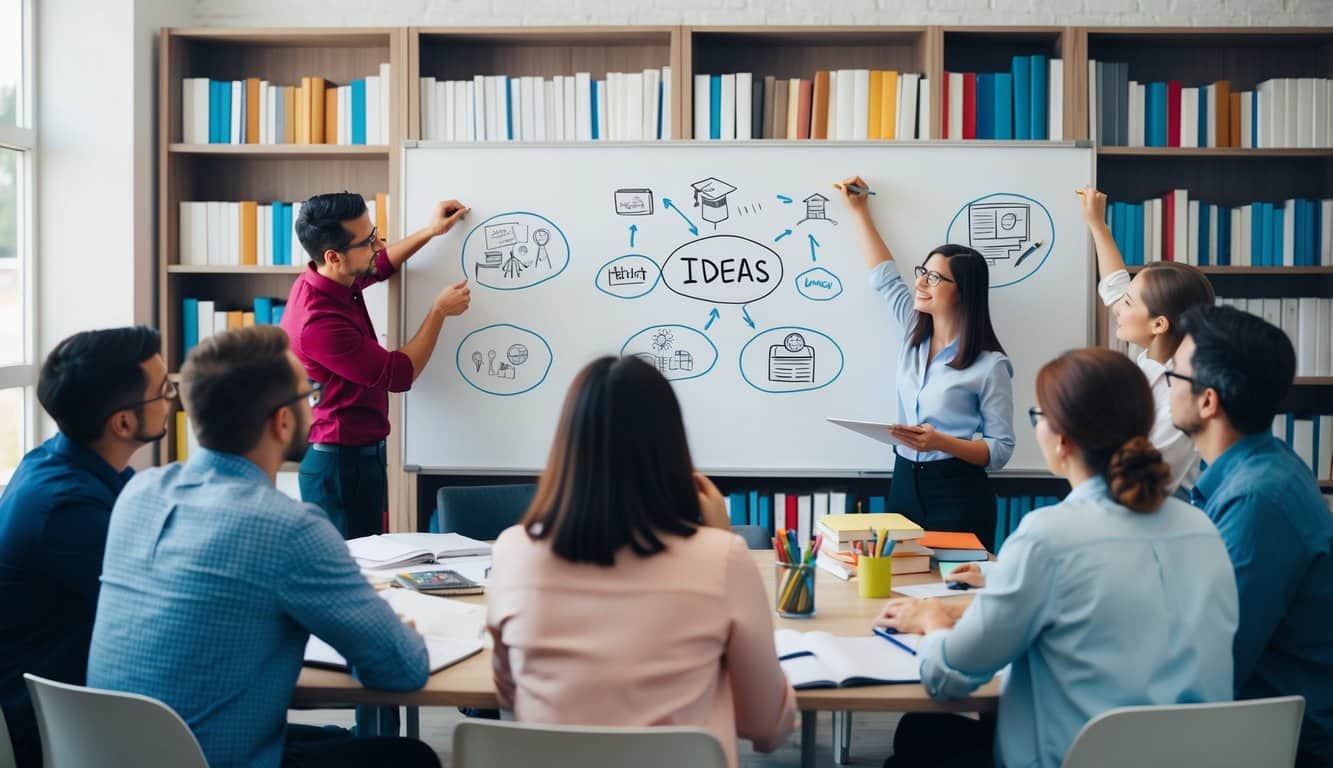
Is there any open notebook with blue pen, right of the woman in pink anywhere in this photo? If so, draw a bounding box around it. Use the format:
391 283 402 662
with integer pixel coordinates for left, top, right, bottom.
773 629 921 689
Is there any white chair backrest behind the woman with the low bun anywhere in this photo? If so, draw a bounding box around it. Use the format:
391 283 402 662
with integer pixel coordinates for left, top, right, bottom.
1064 696 1305 768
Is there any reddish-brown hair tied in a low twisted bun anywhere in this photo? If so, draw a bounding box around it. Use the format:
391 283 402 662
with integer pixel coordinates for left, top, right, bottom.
1037 347 1170 512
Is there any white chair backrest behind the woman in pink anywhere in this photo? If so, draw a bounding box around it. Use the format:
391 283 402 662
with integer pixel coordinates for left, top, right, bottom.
451 720 726 768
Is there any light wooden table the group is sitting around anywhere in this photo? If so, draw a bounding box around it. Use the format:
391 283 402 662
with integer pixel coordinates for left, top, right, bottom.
292 549 1000 768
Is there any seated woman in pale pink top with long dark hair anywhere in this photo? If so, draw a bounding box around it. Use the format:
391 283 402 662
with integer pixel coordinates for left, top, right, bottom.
487 357 796 767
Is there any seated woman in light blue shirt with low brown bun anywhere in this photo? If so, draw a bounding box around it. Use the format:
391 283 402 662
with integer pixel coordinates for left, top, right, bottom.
876 348 1237 768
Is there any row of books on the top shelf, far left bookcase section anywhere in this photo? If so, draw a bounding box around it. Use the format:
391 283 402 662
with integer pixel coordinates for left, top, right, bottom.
181 64 392 144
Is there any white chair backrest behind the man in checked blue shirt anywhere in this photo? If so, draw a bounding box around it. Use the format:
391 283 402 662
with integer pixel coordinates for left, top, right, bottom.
24 675 208 768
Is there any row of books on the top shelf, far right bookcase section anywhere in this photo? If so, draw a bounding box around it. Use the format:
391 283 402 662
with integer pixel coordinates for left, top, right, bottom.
1088 61 1333 148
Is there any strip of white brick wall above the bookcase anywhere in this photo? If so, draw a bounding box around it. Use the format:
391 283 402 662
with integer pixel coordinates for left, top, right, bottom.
195 0 1333 27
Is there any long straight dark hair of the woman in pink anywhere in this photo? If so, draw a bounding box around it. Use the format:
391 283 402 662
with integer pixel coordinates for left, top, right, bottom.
521 357 701 565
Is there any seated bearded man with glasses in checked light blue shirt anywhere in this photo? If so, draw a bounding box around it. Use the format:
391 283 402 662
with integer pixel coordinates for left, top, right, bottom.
88 325 439 768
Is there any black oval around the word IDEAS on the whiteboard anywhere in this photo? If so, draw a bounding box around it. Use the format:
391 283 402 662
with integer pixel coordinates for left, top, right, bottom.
663 235 782 304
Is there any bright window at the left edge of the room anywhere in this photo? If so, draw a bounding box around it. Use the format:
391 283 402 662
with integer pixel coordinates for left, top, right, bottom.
0 0 37 485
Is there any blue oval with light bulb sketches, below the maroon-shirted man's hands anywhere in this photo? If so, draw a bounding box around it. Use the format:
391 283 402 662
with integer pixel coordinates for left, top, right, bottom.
455 323 555 397
